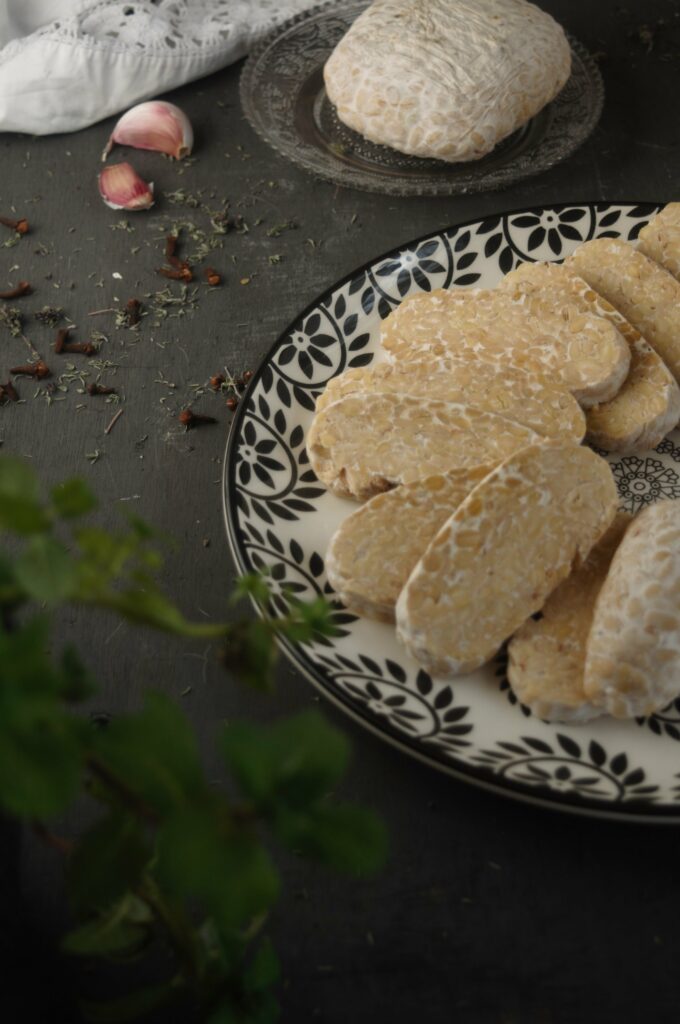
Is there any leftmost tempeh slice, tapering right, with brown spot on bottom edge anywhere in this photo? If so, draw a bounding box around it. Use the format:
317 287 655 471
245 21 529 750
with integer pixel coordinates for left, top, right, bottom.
307 394 541 501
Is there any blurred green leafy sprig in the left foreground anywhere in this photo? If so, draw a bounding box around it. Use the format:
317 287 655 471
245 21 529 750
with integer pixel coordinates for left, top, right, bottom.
0 458 385 1024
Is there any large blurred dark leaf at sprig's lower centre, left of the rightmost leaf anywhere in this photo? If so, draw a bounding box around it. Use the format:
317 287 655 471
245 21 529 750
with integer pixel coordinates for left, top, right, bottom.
158 799 279 932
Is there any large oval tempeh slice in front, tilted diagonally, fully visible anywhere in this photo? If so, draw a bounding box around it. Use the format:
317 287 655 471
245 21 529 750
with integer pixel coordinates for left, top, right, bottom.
396 440 617 676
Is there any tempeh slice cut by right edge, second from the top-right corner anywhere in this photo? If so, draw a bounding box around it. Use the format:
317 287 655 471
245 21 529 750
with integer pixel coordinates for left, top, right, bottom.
566 239 680 381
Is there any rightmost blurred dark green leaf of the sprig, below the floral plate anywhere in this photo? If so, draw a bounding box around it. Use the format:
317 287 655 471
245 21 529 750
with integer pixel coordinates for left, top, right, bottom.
272 803 387 876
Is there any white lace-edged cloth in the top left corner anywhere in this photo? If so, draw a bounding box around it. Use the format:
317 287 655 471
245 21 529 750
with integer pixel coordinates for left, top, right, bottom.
0 0 317 135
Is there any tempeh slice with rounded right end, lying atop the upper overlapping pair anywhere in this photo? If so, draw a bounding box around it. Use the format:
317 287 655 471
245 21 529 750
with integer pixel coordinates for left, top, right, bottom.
381 289 631 408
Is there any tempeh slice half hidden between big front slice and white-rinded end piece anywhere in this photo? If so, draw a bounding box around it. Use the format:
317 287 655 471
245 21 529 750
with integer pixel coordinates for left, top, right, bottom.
508 512 631 722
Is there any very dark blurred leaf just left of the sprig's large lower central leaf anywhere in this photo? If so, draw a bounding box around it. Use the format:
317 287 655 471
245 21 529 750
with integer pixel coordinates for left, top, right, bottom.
67 810 151 912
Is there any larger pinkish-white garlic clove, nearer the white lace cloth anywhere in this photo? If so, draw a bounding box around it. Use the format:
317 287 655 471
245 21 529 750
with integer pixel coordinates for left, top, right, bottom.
101 99 194 161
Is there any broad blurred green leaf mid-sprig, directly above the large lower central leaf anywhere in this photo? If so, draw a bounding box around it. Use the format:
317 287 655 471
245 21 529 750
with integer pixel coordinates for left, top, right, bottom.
93 693 207 814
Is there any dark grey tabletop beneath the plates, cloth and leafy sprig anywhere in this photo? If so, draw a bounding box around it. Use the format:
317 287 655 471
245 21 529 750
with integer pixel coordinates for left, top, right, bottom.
0 0 680 1024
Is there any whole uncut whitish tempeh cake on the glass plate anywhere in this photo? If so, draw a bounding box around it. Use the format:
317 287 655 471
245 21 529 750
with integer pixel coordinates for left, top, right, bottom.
324 0 570 161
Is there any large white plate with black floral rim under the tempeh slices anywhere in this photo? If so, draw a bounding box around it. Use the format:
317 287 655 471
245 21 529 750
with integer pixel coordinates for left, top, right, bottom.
224 203 680 822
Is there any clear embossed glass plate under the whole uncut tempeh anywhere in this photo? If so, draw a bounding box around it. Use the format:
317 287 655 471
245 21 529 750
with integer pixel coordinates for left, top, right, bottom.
241 0 603 196
